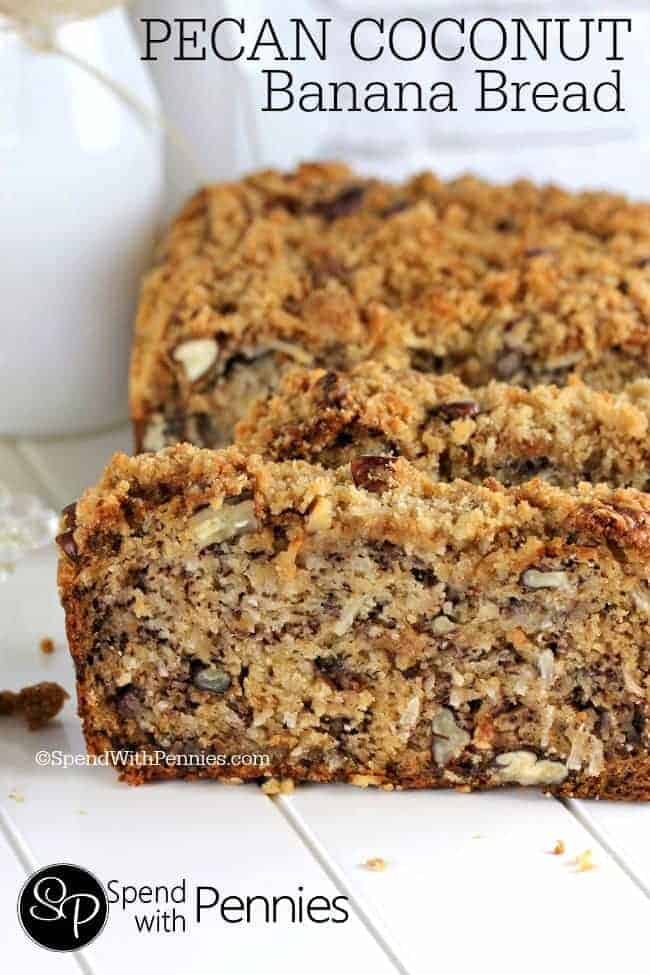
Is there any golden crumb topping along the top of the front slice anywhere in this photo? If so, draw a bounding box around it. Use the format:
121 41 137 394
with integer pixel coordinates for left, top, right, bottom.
59 444 650 580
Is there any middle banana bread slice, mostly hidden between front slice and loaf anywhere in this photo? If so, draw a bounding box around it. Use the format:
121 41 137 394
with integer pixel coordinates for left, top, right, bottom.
236 362 650 491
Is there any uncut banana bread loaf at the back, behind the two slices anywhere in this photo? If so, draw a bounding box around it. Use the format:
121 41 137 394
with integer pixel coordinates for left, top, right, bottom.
131 164 650 450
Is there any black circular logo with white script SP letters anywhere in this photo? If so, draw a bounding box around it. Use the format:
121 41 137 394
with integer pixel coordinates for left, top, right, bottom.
18 863 108 951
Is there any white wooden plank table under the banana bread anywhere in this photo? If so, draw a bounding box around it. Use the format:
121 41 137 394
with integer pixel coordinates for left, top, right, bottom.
0 429 650 975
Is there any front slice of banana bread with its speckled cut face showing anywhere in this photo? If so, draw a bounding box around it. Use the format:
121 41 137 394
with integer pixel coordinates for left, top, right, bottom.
59 445 650 799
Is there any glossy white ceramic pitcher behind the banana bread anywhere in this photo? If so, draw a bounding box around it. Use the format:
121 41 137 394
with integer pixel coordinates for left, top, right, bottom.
0 9 163 436
